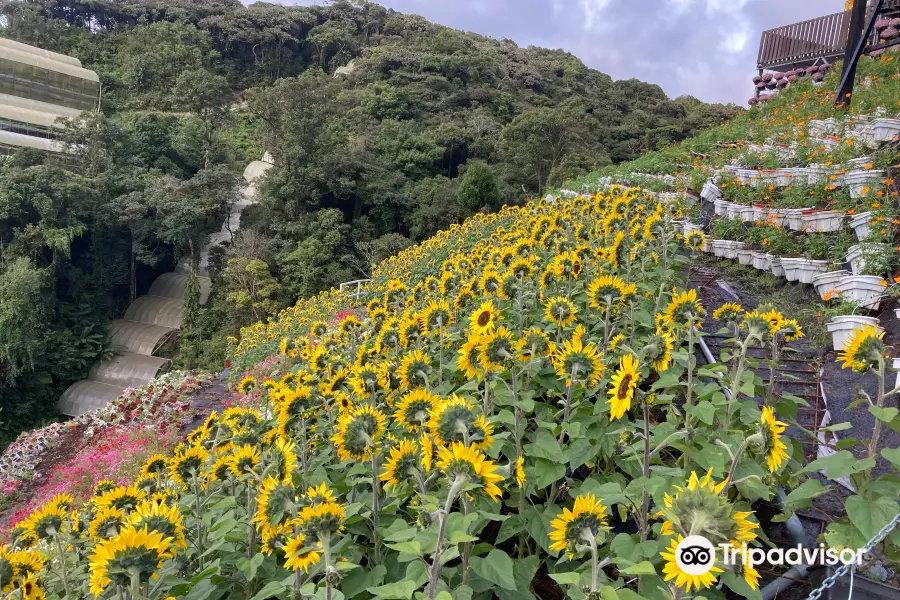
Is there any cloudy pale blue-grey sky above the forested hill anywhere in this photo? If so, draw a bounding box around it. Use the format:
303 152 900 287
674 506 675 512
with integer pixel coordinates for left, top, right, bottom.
270 0 844 105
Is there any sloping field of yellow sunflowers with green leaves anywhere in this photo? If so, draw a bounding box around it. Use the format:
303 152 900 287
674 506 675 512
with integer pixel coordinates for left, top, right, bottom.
0 187 832 600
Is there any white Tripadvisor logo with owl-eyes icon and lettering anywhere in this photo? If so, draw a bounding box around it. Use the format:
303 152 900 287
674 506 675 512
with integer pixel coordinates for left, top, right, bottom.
675 535 866 576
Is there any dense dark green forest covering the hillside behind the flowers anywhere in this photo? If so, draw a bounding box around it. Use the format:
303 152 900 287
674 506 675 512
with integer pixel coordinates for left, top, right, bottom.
0 0 740 446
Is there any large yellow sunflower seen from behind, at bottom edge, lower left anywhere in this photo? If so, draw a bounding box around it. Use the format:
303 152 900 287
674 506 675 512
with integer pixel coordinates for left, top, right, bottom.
90 527 172 596
